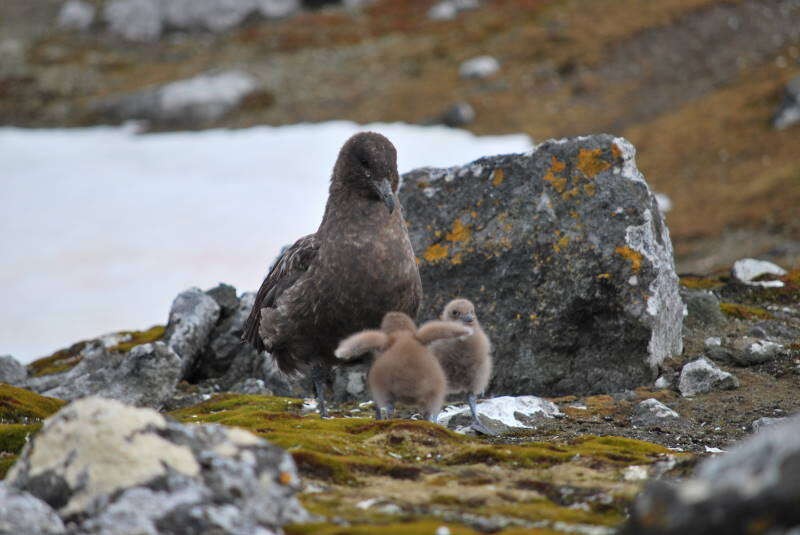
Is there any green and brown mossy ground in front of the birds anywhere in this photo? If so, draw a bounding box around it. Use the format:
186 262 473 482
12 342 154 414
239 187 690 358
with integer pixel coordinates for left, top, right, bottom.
170 394 672 534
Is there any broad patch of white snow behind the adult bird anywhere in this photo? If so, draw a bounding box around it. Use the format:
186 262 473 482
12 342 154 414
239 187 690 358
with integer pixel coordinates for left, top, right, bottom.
0 121 531 362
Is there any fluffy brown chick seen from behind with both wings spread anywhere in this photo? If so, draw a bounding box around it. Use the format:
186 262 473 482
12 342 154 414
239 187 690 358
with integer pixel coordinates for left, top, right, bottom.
336 312 472 422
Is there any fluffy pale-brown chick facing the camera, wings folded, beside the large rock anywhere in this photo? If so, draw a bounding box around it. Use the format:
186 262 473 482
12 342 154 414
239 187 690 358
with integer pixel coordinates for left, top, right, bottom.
431 299 492 433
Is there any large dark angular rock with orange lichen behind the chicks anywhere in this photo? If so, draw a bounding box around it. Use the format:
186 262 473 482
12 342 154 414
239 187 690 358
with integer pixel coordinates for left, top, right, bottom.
400 134 683 395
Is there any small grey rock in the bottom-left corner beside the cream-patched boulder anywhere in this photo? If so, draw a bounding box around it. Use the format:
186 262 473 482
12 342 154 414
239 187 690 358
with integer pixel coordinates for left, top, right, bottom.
0 481 66 535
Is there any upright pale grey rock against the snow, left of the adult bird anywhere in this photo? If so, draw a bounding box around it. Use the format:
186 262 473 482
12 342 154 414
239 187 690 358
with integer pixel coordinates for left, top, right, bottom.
164 288 220 378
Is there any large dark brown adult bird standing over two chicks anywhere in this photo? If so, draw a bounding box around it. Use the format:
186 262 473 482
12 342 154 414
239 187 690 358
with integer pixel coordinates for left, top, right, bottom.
242 132 422 415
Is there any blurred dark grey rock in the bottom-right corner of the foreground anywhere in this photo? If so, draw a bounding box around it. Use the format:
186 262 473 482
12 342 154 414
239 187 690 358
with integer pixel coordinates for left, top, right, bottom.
622 417 800 535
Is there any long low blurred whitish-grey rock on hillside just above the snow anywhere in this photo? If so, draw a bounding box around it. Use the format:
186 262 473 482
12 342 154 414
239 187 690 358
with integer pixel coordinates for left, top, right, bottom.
93 70 256 126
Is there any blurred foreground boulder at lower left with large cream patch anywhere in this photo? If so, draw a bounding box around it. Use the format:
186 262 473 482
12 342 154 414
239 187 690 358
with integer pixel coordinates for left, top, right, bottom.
6 397 308 535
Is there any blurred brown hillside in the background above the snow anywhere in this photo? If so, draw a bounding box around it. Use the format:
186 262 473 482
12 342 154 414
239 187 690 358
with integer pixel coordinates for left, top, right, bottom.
0 0 800 271
